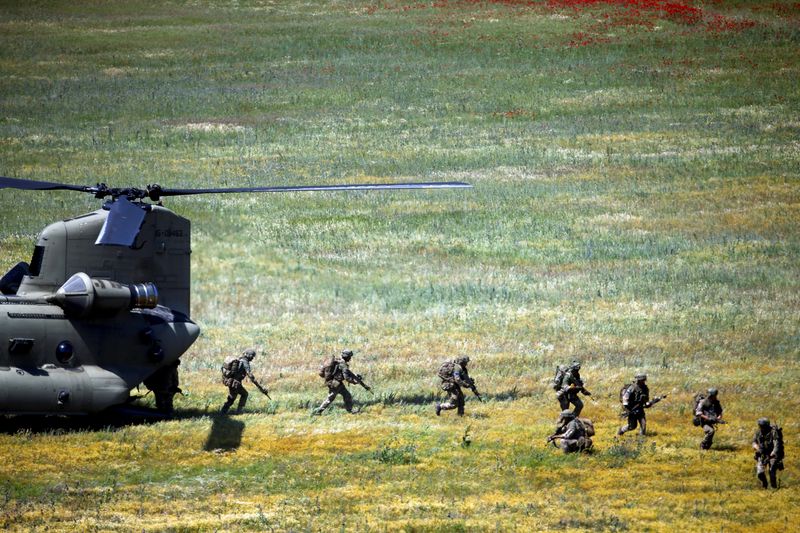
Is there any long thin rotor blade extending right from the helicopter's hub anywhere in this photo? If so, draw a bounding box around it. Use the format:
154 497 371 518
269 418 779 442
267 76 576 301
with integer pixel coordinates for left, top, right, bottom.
148 181 472 200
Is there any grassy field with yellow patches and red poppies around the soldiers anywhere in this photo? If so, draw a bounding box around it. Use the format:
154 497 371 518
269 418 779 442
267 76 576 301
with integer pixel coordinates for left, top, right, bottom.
0 0 800 531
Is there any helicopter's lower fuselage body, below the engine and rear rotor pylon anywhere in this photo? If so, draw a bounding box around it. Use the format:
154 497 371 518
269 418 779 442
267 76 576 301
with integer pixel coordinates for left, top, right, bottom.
0 296 200 414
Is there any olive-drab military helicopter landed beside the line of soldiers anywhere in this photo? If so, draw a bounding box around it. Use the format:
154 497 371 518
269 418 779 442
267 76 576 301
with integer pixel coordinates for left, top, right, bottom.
0 177 471 415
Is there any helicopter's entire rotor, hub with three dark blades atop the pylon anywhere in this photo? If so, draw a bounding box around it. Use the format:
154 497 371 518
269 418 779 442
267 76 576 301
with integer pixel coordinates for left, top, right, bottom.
0 176 472 246
